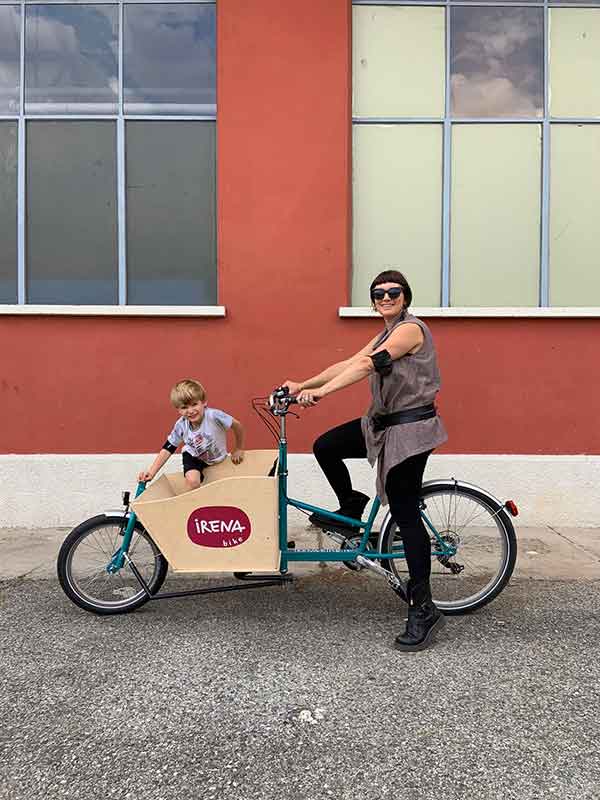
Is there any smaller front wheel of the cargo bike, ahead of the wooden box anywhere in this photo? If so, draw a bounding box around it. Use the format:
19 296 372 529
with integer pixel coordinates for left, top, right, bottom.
57 514 168 614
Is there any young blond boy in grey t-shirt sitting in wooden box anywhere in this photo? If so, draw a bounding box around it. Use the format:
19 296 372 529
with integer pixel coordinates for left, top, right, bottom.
138 380 244 489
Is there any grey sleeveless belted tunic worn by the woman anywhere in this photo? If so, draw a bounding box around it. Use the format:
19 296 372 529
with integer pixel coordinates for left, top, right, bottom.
361 313 448 505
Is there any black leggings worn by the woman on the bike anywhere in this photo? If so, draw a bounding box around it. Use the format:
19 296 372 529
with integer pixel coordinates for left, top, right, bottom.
313 419 431 585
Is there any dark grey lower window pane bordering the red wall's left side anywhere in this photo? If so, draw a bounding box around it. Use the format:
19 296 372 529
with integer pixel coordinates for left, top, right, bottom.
126 122 217 305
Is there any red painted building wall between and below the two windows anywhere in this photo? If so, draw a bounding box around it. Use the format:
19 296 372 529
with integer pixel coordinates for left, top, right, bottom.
0 0 600 453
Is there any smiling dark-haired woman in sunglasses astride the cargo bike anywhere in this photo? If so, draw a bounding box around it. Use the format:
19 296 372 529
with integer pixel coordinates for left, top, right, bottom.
284 270 447 651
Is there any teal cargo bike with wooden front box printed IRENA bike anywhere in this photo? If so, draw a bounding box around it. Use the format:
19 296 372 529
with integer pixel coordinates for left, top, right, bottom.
57 387 518 615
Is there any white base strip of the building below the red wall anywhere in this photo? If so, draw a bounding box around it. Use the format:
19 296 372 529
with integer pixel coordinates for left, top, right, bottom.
0 454 600 528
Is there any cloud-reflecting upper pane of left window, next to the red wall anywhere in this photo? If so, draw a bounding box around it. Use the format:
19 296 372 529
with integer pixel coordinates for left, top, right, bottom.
124 4 216 115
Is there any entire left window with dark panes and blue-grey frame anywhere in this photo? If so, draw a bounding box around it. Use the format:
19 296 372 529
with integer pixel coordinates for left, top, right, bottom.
0 0 217 306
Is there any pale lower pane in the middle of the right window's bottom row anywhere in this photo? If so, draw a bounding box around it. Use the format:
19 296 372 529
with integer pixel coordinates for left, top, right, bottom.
450 125 541 306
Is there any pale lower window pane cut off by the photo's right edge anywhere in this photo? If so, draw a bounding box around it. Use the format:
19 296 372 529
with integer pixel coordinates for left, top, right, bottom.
550 125 600 306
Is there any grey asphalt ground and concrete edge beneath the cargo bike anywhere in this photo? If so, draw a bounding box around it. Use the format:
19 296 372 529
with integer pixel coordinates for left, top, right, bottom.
0 530 600 800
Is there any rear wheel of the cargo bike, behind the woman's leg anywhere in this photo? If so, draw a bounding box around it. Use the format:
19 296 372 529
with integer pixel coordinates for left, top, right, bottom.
381 481 517 615
